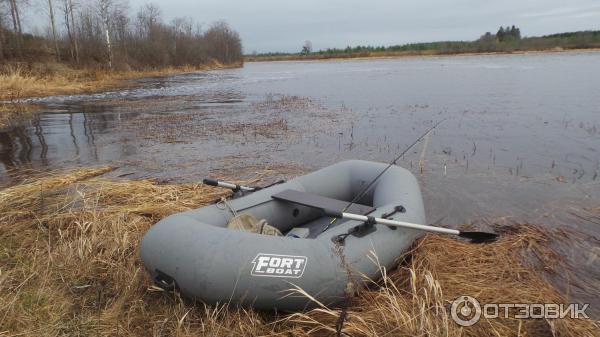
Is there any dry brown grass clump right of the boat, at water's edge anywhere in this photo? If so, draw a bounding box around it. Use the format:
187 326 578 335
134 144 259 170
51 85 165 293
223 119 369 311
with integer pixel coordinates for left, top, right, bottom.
289 226 600 336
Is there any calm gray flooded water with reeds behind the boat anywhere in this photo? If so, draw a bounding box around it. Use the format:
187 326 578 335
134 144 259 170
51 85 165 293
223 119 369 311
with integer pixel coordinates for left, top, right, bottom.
0 52 600 312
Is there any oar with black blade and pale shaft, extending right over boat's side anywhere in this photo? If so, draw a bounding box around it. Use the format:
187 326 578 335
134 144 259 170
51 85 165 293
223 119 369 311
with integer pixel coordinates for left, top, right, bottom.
325 210 498 243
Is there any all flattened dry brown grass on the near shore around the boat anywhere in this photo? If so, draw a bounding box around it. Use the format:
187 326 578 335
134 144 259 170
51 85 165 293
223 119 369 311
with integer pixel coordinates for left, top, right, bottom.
0 168 599 336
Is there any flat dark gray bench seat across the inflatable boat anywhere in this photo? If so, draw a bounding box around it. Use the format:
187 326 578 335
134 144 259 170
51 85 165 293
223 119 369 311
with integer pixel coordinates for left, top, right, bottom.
271 190 375 215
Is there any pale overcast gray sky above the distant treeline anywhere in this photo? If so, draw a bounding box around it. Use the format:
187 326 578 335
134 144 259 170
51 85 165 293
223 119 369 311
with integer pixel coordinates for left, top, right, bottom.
32 0 600 53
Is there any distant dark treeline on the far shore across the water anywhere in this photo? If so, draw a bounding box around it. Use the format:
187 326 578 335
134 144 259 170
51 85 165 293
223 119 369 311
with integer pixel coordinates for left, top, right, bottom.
246 26 600 61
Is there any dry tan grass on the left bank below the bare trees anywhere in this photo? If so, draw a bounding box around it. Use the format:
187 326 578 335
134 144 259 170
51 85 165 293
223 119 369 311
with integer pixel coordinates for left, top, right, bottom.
0 62 239 100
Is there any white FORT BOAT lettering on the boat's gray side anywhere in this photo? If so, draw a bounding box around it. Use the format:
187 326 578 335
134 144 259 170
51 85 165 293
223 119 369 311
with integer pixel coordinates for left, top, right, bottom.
250 253 308 278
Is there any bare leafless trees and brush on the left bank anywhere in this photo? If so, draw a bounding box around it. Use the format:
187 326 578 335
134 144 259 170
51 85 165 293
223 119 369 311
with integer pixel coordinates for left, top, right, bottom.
0 0 242 71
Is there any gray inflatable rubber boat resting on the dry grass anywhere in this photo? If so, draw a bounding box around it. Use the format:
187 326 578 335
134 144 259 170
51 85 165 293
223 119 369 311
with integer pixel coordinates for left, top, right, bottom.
141 160 425 310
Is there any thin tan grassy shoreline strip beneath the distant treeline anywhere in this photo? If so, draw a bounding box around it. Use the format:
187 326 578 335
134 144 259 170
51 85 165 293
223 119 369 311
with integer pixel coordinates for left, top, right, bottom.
244 47 600 62
